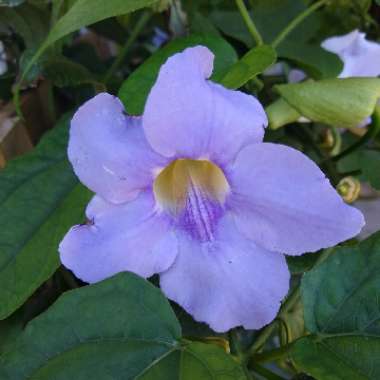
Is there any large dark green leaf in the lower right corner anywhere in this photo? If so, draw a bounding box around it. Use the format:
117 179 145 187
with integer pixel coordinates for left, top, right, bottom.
291 233 380 380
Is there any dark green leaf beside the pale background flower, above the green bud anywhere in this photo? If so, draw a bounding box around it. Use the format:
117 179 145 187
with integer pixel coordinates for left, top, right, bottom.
277 41 343 79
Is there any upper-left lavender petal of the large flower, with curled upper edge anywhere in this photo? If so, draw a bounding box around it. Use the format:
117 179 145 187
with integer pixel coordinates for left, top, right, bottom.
68 93 166 203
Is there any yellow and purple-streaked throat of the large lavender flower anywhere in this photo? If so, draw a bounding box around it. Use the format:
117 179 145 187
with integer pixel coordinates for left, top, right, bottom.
153 159 230 241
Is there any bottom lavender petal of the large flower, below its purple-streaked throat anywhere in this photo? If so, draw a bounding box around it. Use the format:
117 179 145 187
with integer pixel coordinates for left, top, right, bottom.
160 216 289 332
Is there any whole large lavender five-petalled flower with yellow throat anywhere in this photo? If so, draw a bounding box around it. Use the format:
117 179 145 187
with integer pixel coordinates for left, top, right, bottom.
60 46 364 331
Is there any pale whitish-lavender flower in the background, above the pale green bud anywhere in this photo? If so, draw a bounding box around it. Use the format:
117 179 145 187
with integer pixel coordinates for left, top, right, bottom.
321 29 380 78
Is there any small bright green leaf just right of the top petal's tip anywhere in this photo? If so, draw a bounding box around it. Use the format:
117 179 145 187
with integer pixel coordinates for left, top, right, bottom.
220 45 277 89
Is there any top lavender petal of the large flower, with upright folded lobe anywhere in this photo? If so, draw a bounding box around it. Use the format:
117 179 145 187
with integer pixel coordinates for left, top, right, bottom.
143 46 268 165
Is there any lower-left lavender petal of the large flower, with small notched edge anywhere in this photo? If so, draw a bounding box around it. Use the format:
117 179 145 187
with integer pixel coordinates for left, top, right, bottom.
59 193 177 283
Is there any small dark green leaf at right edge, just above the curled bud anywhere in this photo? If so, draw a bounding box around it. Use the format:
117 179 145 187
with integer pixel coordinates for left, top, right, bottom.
338 149 380 190
